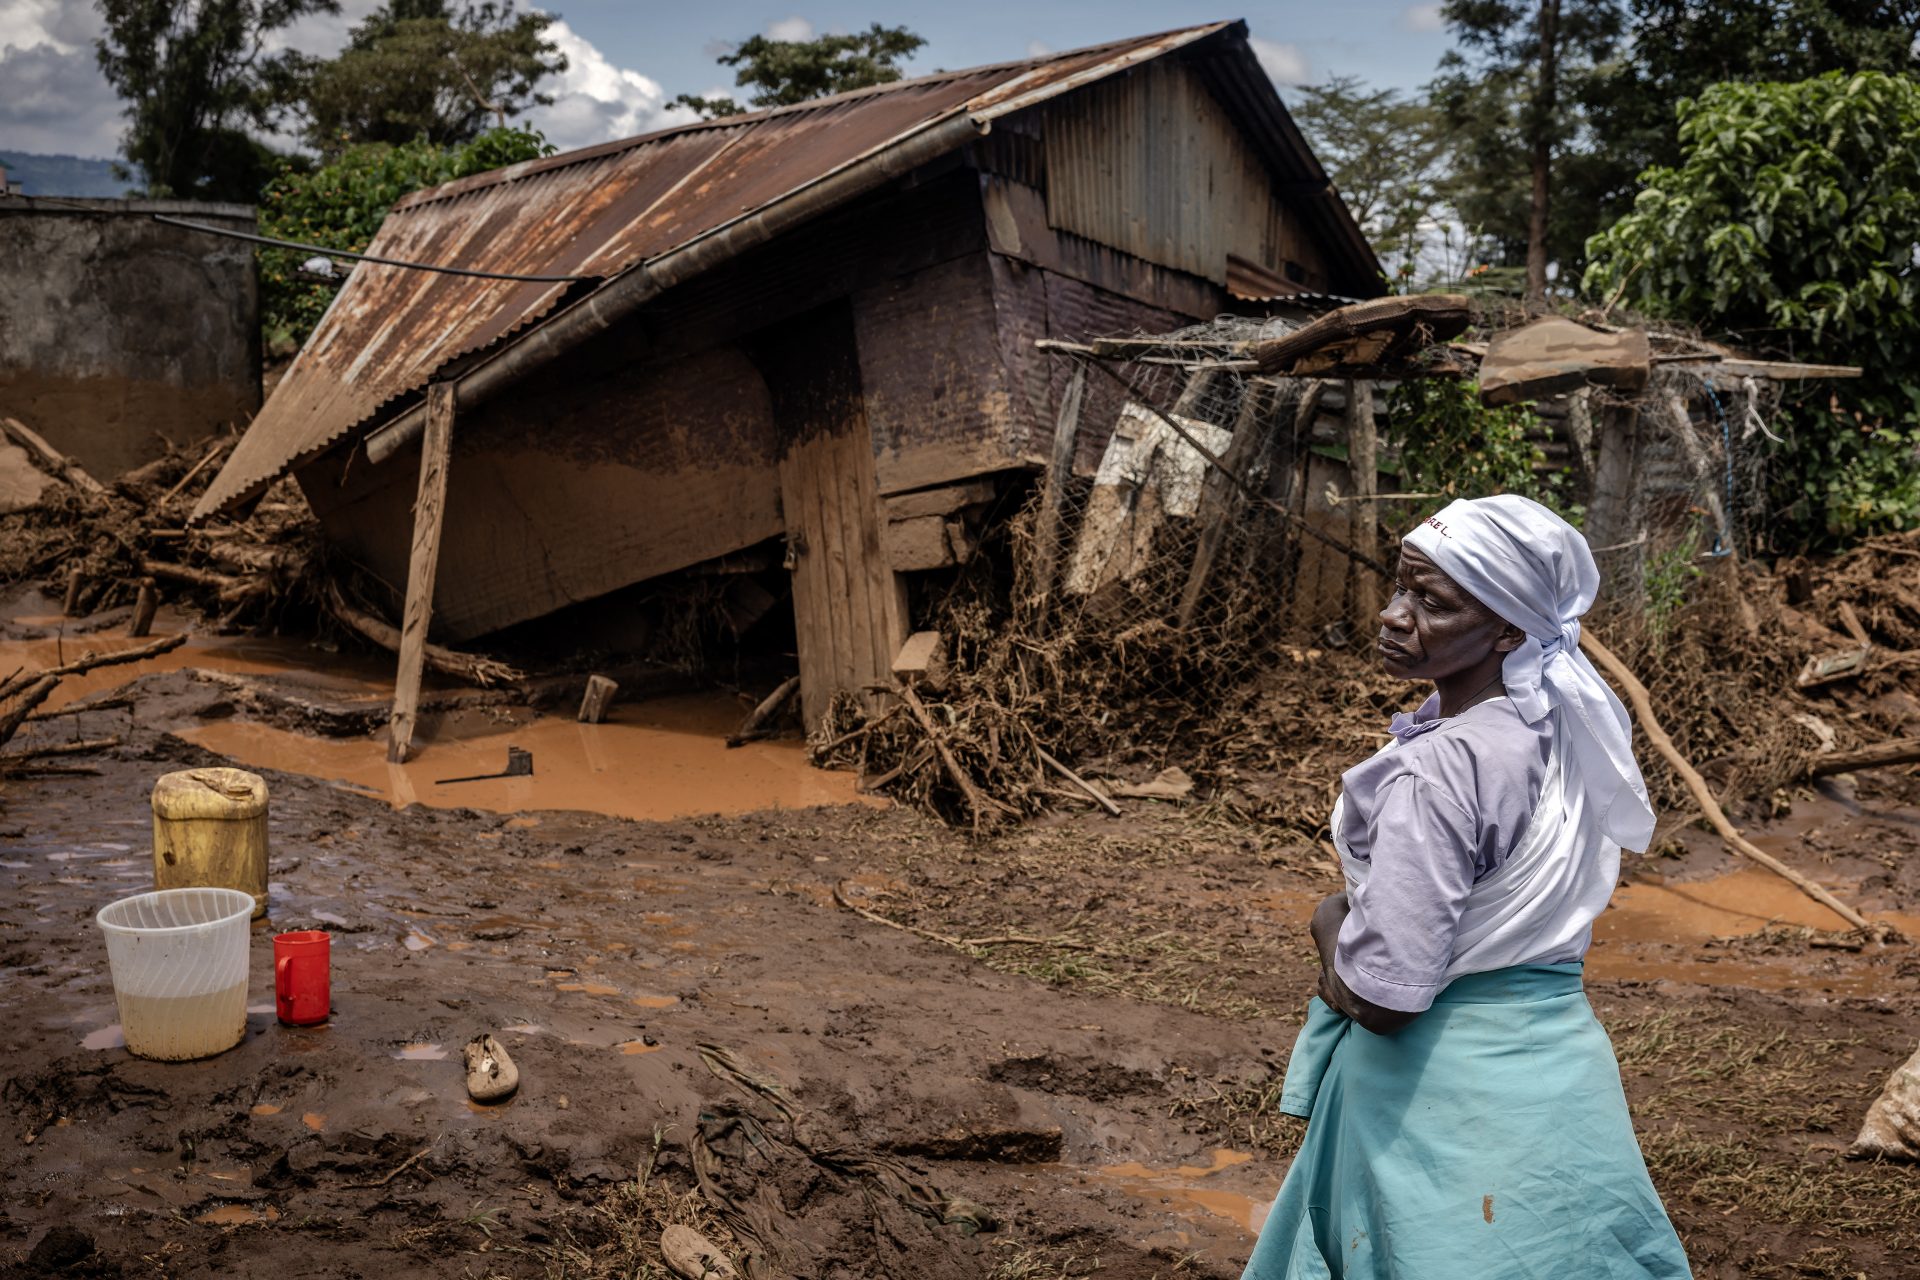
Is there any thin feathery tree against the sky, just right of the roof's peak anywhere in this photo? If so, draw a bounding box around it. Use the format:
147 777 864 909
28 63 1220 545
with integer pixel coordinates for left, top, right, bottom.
1290 75 1448 278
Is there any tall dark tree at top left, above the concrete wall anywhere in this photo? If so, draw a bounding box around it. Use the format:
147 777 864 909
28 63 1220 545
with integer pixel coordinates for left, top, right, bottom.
94 0 340 201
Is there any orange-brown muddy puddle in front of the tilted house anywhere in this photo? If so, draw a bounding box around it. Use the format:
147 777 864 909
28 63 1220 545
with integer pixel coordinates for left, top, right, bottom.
180 693 885 821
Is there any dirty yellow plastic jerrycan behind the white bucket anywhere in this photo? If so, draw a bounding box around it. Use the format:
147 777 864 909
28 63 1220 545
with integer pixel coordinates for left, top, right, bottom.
154 768 267 919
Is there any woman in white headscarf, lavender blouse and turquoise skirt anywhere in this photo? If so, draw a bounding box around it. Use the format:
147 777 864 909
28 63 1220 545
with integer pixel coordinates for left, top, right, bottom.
1246 495 1690 1280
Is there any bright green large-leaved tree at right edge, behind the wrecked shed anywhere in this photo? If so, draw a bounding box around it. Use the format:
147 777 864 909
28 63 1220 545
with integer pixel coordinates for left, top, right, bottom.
1584 71 1920 543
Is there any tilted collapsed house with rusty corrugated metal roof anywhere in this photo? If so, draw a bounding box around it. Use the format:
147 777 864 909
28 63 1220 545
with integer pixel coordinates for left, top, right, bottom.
194 23 1380 736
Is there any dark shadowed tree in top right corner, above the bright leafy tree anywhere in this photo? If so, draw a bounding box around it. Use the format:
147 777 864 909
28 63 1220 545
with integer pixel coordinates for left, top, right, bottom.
1561 0 1920 234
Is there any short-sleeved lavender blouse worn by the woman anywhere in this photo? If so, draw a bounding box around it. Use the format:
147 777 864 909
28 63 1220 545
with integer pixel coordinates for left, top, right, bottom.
1334 693 1586 1011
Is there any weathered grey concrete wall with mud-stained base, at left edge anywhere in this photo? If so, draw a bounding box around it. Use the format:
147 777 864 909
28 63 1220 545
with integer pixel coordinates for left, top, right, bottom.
0 198 259 476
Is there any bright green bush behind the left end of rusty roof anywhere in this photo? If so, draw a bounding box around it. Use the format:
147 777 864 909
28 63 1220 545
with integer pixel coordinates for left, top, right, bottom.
259 129 555 351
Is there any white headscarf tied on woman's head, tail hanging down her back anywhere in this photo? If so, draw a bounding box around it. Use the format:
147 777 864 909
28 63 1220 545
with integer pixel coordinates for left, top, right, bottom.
1402 493 1653 850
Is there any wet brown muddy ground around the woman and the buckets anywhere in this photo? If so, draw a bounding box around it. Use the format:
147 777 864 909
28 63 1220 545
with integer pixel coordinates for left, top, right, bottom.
0 620 1920 1280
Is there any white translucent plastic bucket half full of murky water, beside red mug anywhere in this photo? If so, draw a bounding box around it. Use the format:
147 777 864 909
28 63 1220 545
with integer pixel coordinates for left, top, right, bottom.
94 889 253 1061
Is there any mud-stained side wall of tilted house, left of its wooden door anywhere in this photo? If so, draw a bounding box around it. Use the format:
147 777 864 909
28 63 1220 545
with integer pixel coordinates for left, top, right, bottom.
298 332 783 641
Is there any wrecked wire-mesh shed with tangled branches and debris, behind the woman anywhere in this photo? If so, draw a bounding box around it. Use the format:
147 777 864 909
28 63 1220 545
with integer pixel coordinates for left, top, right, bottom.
812 299 1920 831
